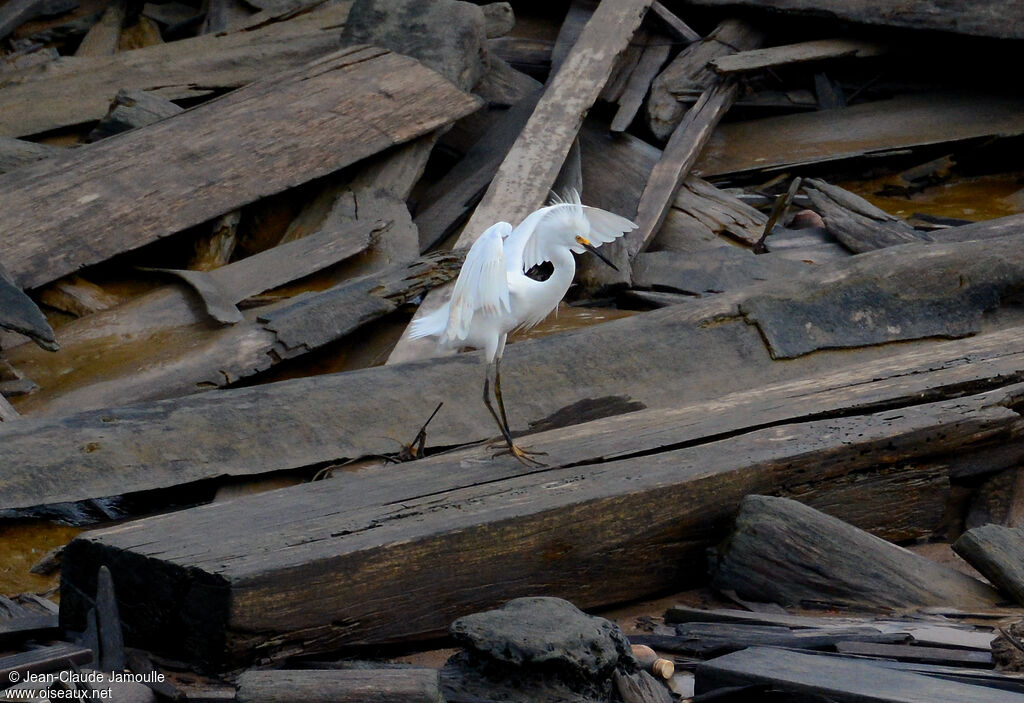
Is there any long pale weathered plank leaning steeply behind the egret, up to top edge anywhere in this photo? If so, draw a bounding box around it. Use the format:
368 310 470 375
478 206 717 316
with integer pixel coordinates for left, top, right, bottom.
388 0 651 363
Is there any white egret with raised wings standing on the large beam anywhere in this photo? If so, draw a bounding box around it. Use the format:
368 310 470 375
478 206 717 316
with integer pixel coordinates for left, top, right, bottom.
410 190 636 466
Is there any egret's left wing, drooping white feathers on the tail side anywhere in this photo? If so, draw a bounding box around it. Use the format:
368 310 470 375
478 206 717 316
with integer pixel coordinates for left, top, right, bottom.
444 222 512 342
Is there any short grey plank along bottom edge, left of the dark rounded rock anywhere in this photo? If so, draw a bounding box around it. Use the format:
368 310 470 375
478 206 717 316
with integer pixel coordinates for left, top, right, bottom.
236 668 444 703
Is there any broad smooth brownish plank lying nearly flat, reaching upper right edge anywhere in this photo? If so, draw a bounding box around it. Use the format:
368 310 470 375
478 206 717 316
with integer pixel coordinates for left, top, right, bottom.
694 93 1024 178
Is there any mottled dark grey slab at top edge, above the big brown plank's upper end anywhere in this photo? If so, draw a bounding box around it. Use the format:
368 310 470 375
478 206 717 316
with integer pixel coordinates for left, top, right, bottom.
341 0 487 90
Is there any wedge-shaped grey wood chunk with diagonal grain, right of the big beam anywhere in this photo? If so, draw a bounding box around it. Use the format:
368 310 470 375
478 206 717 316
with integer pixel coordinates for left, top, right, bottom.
709 495 999 609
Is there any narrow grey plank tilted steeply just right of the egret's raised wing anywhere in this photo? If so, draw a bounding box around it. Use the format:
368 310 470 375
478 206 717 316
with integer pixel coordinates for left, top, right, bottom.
623 80 737 261
